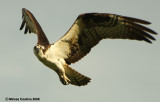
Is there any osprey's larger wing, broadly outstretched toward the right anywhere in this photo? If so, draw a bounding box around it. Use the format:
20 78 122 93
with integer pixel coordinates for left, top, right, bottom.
54 13 156 64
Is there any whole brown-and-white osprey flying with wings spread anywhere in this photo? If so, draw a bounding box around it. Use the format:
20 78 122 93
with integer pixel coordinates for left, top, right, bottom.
20 8 157 86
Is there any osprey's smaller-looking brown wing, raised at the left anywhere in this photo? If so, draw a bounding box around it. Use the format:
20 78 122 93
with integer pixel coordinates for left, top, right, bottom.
20 8 49 46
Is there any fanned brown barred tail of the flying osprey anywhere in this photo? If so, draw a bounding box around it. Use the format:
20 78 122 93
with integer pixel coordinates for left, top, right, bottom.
65 66 91 86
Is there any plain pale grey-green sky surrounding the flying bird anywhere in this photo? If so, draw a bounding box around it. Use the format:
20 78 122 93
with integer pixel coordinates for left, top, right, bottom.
0 0 160 102
